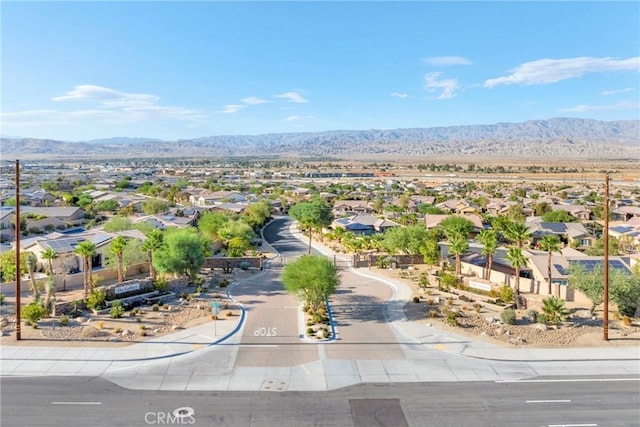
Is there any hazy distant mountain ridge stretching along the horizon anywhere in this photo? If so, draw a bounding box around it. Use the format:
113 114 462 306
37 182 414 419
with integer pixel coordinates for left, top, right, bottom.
0 118 640 159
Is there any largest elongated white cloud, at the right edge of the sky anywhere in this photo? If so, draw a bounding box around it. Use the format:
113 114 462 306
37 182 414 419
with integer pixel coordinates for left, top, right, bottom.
484 56 640 88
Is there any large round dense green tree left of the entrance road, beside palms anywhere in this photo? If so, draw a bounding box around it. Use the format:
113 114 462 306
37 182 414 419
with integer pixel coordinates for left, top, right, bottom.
153 229 208 282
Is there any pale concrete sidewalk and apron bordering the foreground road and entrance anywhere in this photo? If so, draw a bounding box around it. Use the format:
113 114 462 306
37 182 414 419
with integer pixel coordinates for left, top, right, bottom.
0 221 640 390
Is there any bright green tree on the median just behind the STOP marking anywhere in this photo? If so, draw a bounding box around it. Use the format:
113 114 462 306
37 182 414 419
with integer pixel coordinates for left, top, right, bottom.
282 255 340 311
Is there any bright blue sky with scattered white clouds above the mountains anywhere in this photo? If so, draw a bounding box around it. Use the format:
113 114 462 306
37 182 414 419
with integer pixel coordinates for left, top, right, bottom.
0 1 640 141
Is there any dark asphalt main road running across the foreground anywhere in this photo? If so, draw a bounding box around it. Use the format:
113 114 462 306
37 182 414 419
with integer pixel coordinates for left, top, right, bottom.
1 377 640 427
